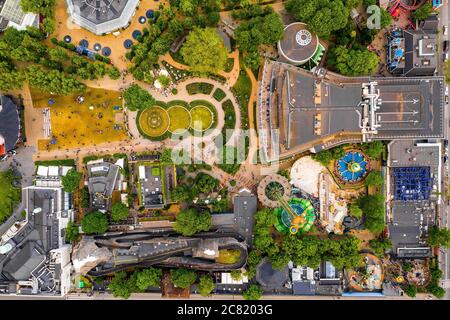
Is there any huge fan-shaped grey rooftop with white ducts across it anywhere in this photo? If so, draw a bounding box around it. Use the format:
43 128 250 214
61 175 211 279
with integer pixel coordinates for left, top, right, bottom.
258 61 444 158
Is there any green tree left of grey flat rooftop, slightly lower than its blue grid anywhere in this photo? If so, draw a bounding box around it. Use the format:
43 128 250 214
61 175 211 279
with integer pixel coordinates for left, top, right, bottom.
358 194 385 233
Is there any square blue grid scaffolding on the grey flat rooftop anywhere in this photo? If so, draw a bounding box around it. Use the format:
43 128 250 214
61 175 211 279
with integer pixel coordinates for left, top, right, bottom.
393 167 432 201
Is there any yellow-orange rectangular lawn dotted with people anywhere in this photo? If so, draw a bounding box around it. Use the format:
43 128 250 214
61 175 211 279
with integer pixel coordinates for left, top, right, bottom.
31 88 127 150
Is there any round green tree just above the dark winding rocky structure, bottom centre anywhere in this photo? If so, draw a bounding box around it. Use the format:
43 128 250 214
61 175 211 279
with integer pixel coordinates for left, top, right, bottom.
173 209 211 236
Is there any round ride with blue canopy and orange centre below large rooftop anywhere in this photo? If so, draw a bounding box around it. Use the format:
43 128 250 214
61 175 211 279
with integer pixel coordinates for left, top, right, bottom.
336 151 368 183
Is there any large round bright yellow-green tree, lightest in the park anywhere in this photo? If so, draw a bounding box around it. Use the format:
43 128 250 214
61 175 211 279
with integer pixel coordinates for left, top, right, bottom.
180 28 228 74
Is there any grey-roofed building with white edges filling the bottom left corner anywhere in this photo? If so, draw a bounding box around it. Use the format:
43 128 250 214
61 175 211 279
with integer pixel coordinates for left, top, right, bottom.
0 186 72 295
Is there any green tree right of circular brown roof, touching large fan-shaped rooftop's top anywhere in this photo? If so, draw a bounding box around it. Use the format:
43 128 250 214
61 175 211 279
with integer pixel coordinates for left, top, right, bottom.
332 46 379 76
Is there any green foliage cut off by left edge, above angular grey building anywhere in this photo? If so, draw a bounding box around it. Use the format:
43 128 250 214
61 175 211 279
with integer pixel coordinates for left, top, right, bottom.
0 171 21 223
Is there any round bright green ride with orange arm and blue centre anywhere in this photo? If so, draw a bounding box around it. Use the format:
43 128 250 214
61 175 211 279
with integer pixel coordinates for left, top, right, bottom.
274 198 316 235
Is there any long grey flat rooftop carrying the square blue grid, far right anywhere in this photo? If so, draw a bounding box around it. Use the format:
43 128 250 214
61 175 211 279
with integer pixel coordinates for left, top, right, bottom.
387 140 441 258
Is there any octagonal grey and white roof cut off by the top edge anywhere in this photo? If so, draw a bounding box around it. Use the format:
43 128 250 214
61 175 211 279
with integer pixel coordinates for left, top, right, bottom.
66 0 139 35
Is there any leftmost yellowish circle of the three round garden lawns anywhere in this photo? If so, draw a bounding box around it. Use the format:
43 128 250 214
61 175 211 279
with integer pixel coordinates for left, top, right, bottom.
139 106 169 137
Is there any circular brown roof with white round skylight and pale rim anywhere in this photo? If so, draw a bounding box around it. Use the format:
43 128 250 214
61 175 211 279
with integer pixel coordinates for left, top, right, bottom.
278 22 319 64
